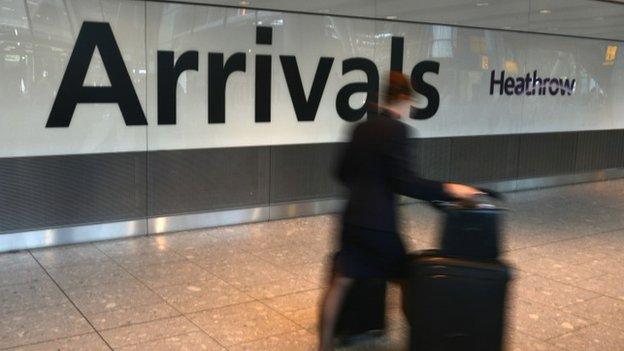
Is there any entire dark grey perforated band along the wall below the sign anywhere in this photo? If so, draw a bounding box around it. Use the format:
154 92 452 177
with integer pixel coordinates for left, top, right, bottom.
0 130 624 233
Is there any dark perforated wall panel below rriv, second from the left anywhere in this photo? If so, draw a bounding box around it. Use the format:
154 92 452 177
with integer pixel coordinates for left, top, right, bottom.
148 147 269 216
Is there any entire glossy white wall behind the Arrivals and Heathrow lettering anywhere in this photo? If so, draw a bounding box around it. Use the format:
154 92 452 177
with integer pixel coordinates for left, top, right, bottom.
0 0 624 157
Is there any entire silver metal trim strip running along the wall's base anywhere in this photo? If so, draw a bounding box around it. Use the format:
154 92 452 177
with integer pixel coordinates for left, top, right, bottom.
0 168 624 252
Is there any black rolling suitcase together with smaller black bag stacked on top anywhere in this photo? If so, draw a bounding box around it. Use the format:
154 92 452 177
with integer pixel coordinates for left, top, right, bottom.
404 194 510 351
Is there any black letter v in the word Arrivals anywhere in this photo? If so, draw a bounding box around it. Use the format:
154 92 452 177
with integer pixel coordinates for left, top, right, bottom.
280 56 334 122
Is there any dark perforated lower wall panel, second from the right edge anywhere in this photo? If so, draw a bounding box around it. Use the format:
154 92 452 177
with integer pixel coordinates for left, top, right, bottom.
518 132 578 178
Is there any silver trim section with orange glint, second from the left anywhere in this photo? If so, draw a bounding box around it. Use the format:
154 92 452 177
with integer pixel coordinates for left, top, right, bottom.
148 206 270 234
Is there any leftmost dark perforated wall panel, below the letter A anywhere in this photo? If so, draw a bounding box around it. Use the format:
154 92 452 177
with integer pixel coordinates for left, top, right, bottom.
0 153 147 232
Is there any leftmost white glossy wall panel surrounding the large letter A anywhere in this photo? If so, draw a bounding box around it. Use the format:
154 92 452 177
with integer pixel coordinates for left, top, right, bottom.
0 0 146 157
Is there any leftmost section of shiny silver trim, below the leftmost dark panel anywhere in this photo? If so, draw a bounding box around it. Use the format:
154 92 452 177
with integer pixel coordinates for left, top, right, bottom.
0 219 147 252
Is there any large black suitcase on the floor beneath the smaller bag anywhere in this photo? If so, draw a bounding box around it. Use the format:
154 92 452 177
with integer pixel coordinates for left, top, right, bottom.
405 252 510 351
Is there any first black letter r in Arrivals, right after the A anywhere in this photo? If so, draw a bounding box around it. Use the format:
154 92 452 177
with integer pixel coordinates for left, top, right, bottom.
157 51 199 124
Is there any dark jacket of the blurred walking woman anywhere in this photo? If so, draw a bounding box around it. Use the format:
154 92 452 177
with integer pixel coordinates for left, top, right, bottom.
338 113 449 231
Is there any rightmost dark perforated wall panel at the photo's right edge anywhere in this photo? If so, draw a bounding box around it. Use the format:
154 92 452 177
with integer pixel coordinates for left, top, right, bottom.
576 130 624 172
